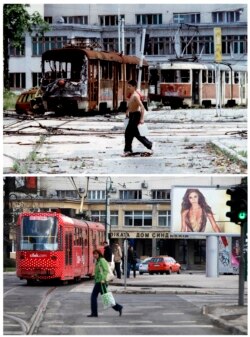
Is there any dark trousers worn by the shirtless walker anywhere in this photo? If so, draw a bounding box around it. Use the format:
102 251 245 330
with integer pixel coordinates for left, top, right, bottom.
124 111 152 152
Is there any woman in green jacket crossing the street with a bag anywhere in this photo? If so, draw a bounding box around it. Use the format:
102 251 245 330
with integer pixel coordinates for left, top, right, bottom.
87 249 123 317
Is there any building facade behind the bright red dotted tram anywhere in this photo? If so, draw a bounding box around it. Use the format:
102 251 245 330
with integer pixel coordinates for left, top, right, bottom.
5 176 241 268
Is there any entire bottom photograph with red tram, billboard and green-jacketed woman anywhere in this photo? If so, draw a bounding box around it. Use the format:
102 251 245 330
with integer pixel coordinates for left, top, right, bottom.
3 175 247 335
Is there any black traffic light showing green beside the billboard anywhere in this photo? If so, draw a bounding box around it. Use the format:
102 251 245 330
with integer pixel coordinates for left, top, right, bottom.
226 185 247 225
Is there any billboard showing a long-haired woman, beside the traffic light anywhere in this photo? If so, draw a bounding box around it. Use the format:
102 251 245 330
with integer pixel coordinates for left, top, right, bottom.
171 186 240 236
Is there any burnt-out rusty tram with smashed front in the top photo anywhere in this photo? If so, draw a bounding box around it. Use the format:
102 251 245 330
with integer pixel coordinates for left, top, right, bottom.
32 42 148 114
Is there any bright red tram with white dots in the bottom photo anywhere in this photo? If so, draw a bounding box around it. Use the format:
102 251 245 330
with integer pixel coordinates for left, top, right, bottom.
16 212 105 284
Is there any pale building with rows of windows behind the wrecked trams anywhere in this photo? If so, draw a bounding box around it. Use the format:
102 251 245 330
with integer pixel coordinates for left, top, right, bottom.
10 3 247 91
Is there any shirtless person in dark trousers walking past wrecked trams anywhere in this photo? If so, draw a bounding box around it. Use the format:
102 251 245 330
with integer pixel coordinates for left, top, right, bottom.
123 80 153 157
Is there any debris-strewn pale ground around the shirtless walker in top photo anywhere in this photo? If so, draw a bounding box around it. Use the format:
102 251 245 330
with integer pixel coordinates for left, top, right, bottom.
3 109 247 174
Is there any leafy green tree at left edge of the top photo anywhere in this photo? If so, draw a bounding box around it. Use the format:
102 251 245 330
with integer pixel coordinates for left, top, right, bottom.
3 4 49 89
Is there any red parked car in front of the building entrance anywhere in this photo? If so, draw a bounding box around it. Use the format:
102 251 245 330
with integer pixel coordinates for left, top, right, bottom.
148 256 181 275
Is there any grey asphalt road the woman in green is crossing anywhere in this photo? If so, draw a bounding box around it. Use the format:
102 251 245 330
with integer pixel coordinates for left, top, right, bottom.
3 275 228 335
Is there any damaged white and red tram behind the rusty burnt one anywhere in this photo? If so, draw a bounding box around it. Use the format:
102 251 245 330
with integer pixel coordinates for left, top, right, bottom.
149 61 248 109
